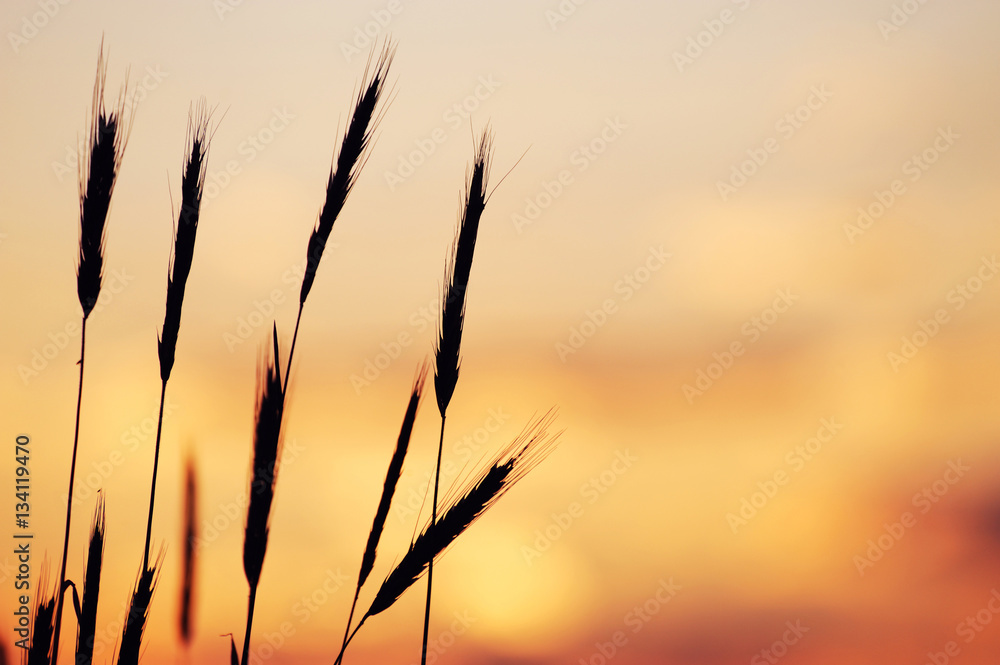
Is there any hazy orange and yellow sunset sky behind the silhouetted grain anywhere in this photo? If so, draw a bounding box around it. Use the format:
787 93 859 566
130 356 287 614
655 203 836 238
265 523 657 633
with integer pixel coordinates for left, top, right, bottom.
0 0 1000 665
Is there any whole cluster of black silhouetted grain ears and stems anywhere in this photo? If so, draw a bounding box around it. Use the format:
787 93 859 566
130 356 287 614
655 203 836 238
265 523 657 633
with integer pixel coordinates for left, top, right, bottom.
26 40 558 665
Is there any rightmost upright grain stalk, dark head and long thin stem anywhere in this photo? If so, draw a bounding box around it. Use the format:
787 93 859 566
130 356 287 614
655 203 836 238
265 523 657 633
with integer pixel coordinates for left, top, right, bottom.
420 126 493 665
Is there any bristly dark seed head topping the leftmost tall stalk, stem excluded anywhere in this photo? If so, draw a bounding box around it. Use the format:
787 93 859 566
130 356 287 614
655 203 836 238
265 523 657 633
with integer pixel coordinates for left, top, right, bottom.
76 48 129 319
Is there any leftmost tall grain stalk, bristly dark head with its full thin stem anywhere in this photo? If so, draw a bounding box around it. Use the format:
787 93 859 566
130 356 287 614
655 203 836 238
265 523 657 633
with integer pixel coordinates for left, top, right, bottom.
52 42 131 663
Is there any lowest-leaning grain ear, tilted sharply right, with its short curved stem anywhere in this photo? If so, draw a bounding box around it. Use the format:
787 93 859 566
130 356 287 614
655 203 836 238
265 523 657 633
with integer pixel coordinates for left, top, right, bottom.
338 411 559 660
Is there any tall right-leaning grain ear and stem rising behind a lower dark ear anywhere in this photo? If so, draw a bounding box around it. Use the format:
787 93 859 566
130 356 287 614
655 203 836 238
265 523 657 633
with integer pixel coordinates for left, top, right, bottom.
285 39 396 390
